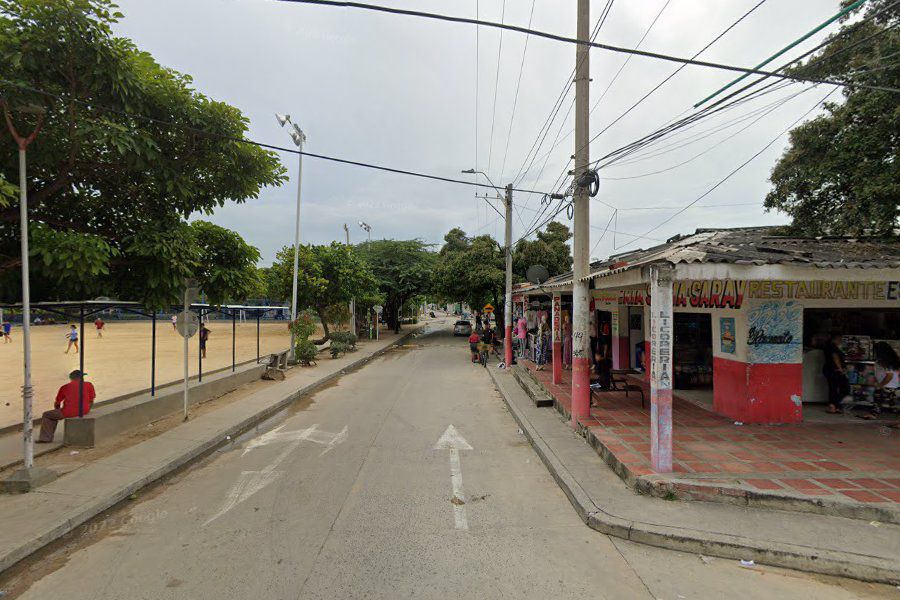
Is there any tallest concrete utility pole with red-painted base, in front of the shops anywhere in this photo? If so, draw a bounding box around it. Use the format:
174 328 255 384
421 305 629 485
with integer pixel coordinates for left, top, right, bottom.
572 0 591 428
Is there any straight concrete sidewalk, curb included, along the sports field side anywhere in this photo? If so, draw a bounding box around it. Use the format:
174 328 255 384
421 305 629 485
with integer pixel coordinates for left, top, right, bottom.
0 321 432 572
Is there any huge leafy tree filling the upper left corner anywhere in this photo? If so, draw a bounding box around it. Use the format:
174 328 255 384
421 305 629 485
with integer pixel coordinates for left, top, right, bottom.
0 0 285 305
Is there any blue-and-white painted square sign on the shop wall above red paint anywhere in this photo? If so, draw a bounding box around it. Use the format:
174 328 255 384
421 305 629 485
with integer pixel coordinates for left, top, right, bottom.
747 301 803 364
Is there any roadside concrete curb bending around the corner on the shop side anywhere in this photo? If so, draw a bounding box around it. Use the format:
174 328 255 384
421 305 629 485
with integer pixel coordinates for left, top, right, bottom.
491 371 900 585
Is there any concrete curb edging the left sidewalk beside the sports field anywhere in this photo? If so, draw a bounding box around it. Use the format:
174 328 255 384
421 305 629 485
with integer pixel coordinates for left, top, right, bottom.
0 323 427 574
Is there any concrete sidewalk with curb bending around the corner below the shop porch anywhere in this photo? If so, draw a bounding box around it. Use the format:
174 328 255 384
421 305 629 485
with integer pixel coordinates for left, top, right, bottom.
491 369 900 584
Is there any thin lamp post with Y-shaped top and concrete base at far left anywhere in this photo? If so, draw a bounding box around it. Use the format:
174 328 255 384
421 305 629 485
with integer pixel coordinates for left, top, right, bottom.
0 101 56 491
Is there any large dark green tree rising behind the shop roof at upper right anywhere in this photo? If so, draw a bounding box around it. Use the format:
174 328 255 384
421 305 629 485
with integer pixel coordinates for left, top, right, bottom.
765 0 900 236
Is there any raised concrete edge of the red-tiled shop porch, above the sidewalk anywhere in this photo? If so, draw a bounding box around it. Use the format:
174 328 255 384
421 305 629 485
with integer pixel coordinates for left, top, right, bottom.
514 367 900 525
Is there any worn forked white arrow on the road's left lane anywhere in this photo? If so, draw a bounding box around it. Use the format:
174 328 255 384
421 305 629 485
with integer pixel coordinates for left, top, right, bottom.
203 425 348 526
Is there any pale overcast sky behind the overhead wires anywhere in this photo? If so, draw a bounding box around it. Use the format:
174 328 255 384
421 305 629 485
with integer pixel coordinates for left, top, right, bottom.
110 0 838 263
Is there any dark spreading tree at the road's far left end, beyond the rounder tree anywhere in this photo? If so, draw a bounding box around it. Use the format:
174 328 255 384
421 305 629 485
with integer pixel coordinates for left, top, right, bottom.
353 239 436 332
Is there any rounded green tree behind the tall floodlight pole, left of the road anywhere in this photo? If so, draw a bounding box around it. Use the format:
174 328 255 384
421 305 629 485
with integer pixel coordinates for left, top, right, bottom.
269 242 376 344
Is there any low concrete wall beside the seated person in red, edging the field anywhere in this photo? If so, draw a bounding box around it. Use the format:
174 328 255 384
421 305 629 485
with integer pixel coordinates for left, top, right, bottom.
63 364 266 448
